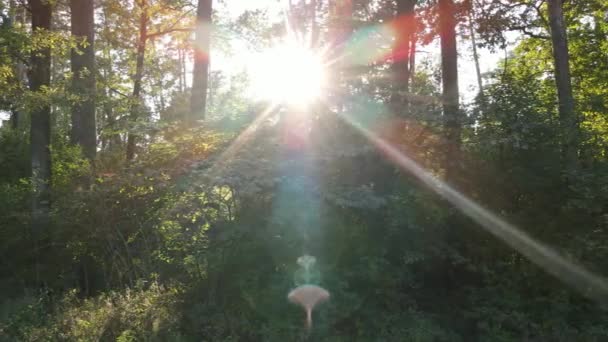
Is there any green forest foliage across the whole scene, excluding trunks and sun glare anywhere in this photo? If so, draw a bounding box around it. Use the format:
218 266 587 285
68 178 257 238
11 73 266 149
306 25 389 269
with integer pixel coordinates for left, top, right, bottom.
0 0 608 341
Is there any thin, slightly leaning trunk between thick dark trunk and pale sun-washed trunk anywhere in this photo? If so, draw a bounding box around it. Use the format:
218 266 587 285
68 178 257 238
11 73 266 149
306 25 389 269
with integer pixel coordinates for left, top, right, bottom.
127 0 149 161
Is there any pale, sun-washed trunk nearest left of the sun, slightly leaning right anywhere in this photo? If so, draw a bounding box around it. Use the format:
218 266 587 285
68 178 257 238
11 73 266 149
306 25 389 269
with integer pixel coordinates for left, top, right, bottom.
189 0 212 122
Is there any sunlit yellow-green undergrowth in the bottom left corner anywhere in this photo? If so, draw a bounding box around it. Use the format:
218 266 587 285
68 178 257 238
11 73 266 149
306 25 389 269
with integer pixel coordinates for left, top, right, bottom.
0 283 181 342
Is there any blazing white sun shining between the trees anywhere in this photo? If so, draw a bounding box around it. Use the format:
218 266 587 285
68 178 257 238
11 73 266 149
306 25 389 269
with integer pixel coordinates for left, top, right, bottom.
249 42 325 106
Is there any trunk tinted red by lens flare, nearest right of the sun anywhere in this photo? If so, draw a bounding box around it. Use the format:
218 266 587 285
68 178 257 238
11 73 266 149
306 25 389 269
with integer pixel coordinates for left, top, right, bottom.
391 0 416 115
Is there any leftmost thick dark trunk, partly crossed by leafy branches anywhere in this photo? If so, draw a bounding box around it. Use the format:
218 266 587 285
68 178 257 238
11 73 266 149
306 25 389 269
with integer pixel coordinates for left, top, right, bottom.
29 0 52 282
